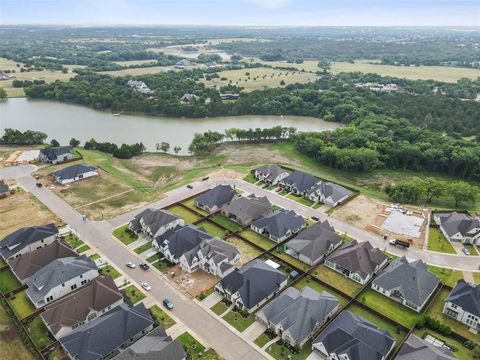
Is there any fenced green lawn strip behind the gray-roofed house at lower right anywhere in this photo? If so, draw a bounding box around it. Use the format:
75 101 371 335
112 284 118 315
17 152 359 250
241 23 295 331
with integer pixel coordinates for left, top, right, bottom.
357 288 420 328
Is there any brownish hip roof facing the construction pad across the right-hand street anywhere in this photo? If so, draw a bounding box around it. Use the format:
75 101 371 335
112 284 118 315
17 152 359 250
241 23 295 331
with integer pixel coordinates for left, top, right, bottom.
328 240 387 278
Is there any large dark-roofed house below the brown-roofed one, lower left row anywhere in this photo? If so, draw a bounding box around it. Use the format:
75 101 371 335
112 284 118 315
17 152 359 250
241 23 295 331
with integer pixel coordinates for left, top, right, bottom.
59 303 153 360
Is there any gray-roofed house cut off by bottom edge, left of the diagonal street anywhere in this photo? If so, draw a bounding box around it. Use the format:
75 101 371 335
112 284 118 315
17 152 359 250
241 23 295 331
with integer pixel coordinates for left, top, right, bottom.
113 326 187 360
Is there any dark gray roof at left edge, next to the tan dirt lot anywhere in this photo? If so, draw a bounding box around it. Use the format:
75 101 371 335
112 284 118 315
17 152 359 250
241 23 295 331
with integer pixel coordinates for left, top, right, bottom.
0 224 58 259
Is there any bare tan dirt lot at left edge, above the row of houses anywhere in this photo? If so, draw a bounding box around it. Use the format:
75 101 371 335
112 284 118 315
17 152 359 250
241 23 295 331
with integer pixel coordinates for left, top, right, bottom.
0 186 61 239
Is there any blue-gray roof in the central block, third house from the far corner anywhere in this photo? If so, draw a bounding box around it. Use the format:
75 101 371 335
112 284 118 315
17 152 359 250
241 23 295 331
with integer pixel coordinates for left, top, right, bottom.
252 210 305 239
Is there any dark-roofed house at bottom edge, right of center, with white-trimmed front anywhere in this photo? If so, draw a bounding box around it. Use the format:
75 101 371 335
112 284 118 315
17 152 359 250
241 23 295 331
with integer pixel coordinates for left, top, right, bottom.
312 310 395 360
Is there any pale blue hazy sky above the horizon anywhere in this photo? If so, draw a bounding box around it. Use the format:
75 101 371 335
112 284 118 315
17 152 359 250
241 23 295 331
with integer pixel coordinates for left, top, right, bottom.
0 0 480 26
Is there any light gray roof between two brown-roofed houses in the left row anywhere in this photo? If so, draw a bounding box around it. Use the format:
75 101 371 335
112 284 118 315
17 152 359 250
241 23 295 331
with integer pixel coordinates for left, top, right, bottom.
25 255 97 303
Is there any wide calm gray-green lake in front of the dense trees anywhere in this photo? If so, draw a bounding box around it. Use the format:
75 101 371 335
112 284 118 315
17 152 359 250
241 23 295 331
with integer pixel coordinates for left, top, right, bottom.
0 98 341 154
